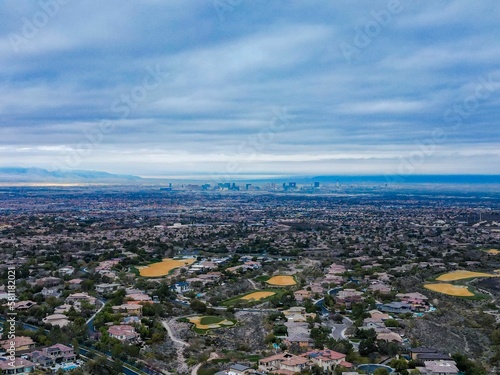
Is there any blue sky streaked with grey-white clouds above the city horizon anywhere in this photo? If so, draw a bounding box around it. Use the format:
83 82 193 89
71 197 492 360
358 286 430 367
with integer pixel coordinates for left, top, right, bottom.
0 0 500 176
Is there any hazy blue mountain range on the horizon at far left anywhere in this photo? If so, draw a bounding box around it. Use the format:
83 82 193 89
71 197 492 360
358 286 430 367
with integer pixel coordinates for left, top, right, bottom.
0 167 142 183
